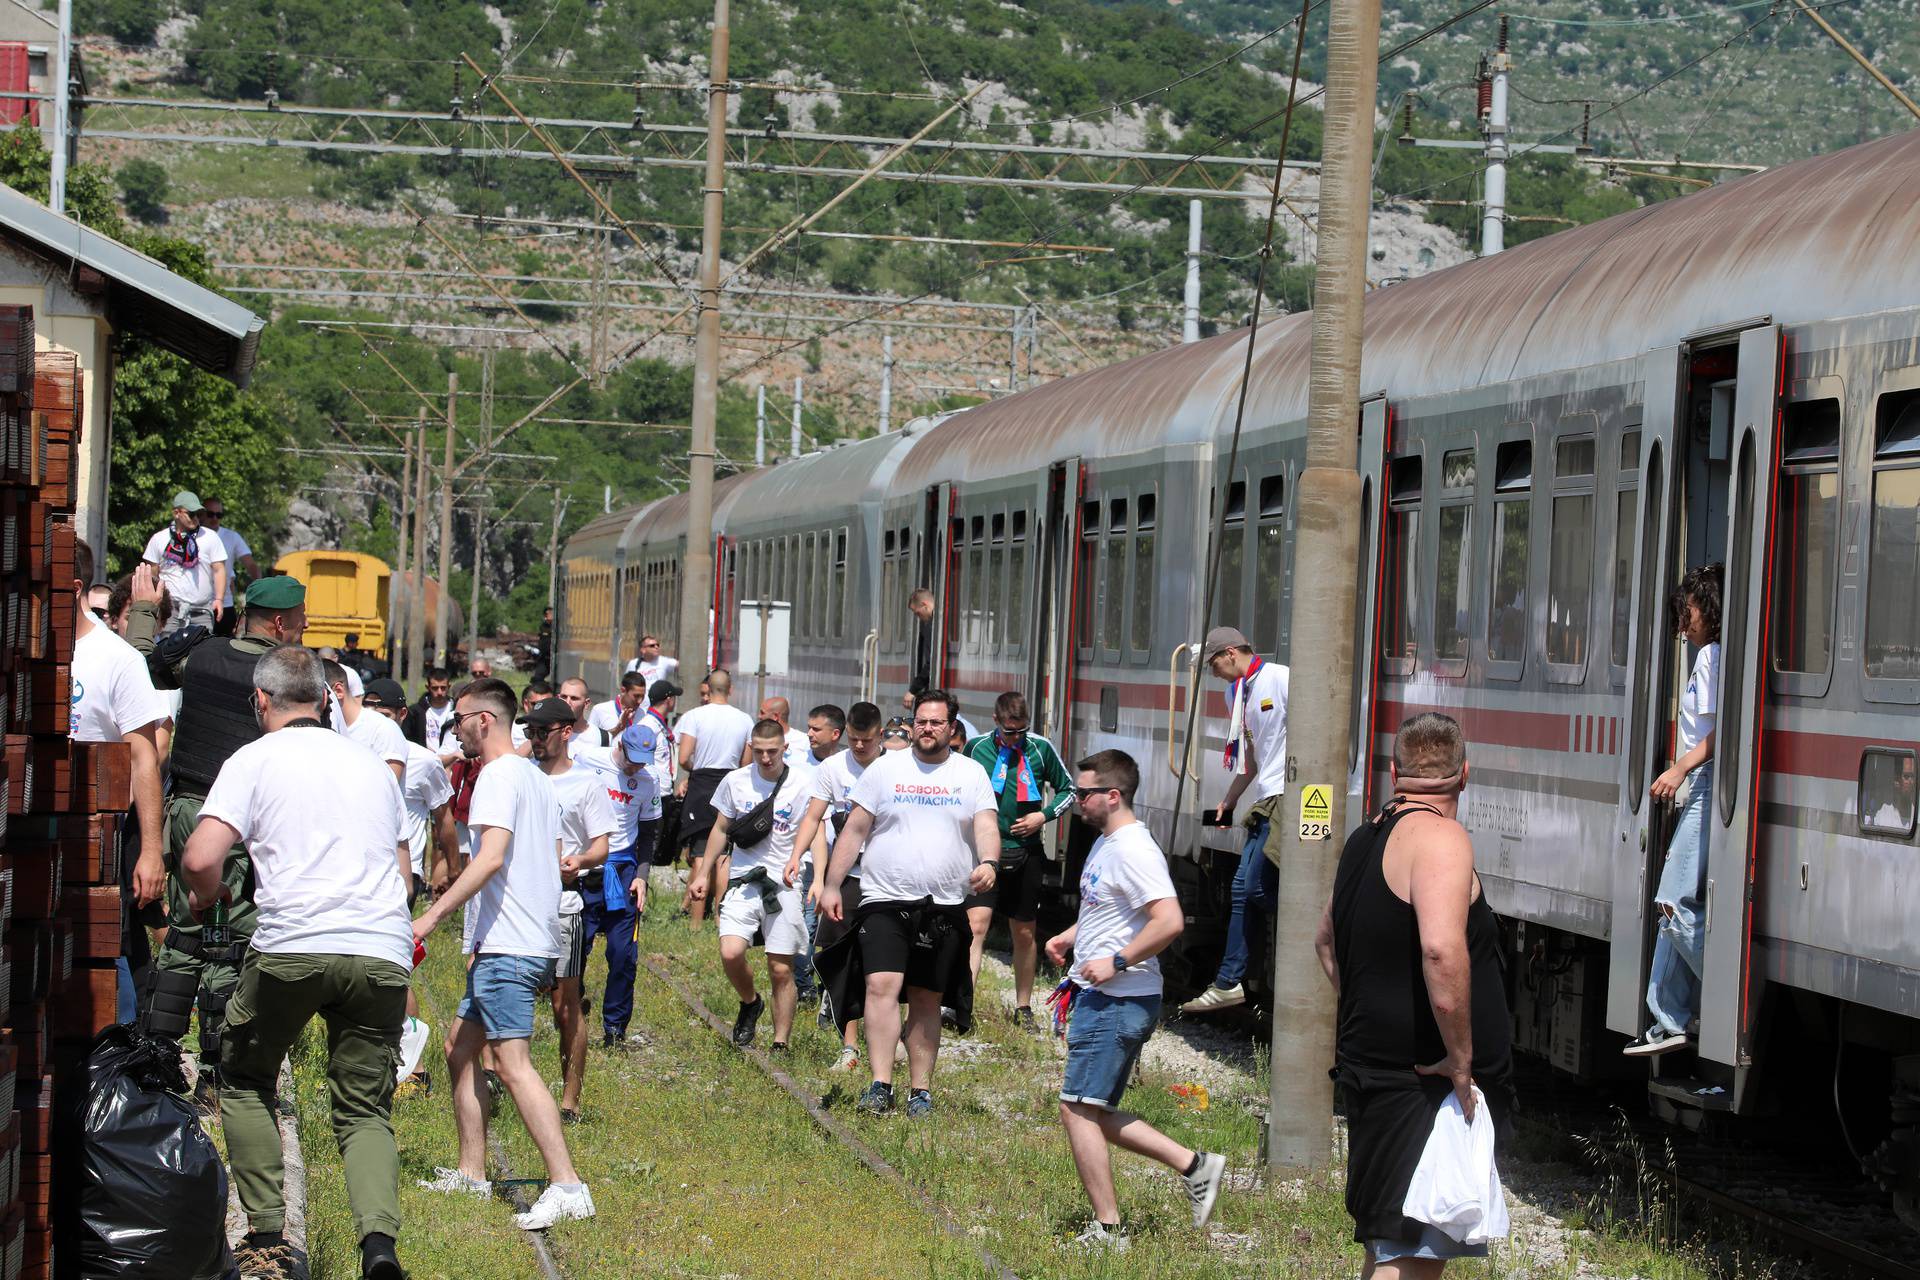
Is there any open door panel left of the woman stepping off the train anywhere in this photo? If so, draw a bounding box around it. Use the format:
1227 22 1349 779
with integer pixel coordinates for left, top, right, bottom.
1607 347 1686 1036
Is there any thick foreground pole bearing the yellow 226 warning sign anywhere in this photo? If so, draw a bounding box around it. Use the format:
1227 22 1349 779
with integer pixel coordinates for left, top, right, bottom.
1267 0 1380 1171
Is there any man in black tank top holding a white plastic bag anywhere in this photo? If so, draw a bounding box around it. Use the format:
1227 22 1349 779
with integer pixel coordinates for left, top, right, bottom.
1315 712 1513 1276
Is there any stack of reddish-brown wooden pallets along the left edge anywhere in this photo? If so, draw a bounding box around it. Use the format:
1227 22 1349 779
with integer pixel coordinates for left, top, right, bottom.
0 333 132 1280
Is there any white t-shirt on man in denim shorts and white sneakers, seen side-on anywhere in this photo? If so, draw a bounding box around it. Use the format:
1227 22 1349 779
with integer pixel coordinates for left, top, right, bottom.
467 752 561 960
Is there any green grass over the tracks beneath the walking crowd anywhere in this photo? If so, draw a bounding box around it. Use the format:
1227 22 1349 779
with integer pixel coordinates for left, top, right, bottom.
280 904 1709 1280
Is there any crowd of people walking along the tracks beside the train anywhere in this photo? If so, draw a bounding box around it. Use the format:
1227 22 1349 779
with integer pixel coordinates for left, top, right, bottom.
73 491 1528 1280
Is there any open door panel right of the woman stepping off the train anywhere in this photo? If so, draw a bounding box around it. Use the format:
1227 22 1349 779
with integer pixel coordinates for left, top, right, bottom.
1699 324 1782 1074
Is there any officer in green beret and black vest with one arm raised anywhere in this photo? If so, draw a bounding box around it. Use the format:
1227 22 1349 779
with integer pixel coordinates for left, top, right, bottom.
127 576 307 1105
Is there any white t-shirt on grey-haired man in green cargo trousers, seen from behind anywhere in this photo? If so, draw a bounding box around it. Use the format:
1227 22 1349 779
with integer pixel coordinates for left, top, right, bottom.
200 727 413 969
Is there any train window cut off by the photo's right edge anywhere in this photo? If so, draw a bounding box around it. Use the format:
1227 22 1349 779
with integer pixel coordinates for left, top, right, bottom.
1866 391 1920 679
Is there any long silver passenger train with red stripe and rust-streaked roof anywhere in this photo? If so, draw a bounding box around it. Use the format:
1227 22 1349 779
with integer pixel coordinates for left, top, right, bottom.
559 130 1920 1196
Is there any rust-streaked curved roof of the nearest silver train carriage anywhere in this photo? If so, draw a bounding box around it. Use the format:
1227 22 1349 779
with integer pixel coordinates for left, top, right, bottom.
893 130 1920 491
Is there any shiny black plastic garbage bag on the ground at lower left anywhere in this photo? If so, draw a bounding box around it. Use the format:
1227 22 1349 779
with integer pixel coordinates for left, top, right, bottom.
73 1027 236 1280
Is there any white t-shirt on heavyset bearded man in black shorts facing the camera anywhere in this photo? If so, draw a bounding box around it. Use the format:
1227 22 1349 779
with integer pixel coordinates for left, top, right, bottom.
851 748 996 906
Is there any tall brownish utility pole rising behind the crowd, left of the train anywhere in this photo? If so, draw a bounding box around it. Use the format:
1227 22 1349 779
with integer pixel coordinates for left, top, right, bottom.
679 0 732 676
